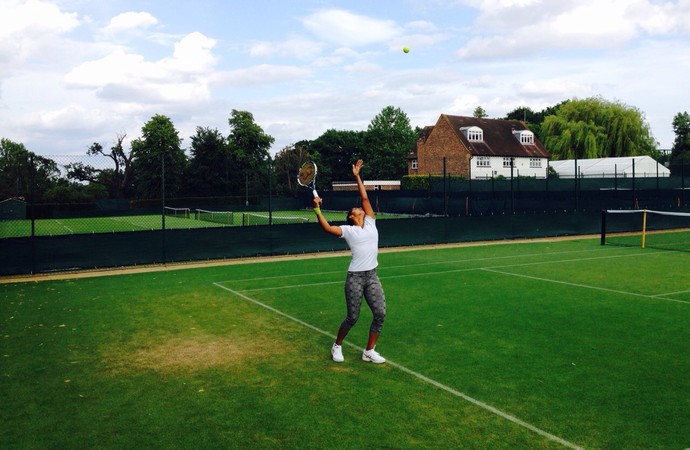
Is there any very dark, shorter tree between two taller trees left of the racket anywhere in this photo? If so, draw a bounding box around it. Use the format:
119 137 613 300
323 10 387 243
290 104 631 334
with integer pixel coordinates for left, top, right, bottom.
185 127 231 196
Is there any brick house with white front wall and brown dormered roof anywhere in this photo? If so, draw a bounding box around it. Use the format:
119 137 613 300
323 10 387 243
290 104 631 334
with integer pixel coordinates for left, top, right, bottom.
407 114 551 179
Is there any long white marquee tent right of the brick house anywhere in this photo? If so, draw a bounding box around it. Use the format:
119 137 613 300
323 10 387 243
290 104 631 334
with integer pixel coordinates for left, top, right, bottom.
549 156 671 178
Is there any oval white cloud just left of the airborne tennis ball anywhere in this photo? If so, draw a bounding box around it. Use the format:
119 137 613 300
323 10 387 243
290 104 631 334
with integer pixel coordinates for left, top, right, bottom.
302 9 402 47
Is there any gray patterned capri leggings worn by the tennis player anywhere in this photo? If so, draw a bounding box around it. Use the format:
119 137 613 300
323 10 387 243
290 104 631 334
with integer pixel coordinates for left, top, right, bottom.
340 269 386 334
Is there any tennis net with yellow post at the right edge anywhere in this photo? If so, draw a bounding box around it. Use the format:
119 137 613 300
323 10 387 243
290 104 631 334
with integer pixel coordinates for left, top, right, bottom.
601 209 690 251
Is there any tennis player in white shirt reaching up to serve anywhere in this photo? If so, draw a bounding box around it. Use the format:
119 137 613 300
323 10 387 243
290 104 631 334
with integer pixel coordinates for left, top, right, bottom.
314 159 386 364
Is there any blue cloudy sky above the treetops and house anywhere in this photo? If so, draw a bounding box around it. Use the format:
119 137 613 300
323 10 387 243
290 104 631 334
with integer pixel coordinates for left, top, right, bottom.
0 0 690 155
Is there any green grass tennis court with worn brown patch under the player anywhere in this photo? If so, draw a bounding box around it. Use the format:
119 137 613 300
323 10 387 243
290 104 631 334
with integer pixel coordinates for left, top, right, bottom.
0 238 690 450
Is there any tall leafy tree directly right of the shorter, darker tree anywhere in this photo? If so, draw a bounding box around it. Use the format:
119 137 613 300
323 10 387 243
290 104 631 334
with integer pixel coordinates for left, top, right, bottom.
228 109 275 194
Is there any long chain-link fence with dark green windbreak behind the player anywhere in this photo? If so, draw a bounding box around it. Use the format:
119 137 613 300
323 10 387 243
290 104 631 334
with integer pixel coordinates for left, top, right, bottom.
0 155 687 275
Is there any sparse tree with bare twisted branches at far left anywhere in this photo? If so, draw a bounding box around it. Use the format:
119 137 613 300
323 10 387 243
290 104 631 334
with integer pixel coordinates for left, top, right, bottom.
65 134 134 199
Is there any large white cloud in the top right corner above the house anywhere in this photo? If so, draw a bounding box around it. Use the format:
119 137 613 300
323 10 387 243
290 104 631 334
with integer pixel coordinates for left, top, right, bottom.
458 0 690 59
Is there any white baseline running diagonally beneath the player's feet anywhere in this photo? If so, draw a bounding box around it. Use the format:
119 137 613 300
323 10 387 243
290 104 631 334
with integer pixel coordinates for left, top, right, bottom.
213 281 582 449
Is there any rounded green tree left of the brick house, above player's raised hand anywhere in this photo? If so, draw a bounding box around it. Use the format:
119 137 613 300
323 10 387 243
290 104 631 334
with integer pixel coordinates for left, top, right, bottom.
364 106 417 180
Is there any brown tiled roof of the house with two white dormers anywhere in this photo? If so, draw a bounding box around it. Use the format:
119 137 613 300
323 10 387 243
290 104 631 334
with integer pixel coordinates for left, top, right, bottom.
439 114 551 158
